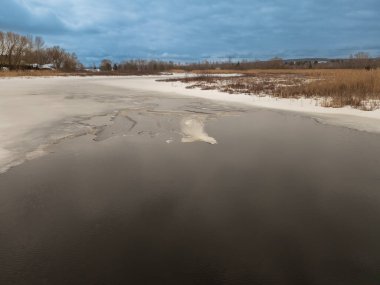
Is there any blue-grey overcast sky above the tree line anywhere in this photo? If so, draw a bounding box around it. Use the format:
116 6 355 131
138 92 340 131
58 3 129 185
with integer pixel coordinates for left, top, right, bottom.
0 0 380 64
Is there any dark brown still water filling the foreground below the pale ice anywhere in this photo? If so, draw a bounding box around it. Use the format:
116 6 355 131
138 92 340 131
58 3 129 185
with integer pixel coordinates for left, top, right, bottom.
0 96 380 285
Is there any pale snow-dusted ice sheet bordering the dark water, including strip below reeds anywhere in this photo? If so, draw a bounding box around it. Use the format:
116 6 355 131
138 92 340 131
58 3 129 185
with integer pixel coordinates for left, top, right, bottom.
0 75 380 173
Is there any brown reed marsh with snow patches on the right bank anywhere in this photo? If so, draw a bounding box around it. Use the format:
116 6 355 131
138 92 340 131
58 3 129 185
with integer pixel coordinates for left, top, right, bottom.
160 69 380 110
